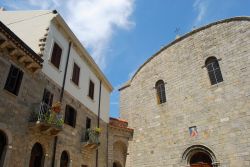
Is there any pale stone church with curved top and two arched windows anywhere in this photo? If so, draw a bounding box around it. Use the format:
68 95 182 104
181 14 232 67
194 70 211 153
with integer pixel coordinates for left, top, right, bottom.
120 17 250 167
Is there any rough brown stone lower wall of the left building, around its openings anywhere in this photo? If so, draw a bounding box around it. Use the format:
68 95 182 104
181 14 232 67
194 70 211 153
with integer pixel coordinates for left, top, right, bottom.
0 47 107 167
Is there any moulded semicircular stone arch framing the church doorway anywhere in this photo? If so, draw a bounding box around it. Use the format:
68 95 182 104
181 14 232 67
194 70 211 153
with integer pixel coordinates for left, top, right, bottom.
182 145 219 167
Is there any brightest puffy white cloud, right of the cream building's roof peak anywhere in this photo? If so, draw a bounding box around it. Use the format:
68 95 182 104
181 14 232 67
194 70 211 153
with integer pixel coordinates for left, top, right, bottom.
67 0 134 68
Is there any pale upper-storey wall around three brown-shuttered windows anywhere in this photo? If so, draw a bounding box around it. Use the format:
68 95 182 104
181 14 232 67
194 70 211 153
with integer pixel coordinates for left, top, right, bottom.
43 23 110 122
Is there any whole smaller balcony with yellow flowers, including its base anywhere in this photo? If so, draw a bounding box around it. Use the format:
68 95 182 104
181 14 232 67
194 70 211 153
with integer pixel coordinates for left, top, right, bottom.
81 128 100 151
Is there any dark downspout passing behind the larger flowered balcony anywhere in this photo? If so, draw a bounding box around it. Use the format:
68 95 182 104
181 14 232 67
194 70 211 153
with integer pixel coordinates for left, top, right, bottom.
51 41 71 167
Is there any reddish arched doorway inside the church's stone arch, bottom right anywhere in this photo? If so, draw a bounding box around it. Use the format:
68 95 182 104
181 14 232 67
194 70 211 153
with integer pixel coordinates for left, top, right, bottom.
189 152 212 167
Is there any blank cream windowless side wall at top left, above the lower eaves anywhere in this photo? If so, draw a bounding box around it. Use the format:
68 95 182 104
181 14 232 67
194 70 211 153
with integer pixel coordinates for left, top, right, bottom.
0 10 55 53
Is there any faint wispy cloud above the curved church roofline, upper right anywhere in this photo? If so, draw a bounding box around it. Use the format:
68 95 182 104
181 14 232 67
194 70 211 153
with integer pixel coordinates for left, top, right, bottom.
193 0 208 26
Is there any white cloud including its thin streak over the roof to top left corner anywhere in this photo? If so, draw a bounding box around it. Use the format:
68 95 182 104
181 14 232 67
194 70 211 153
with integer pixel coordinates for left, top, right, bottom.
4 0 135 69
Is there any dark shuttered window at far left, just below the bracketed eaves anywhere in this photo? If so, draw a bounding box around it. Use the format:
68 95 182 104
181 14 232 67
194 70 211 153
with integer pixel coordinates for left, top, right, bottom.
4 65 23 95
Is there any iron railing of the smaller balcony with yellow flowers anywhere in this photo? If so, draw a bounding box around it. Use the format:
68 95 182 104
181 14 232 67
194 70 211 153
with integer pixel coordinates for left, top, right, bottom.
82 129 100 145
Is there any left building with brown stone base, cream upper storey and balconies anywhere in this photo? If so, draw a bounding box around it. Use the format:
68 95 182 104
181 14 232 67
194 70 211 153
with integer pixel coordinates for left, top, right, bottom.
0 11 133 167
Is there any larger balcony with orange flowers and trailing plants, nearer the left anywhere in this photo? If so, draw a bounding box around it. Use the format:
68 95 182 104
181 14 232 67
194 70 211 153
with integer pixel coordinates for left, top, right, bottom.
29 102 63 136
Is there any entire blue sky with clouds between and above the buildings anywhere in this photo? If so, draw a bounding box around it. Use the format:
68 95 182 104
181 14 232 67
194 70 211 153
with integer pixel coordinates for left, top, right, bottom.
0 0 250 117
